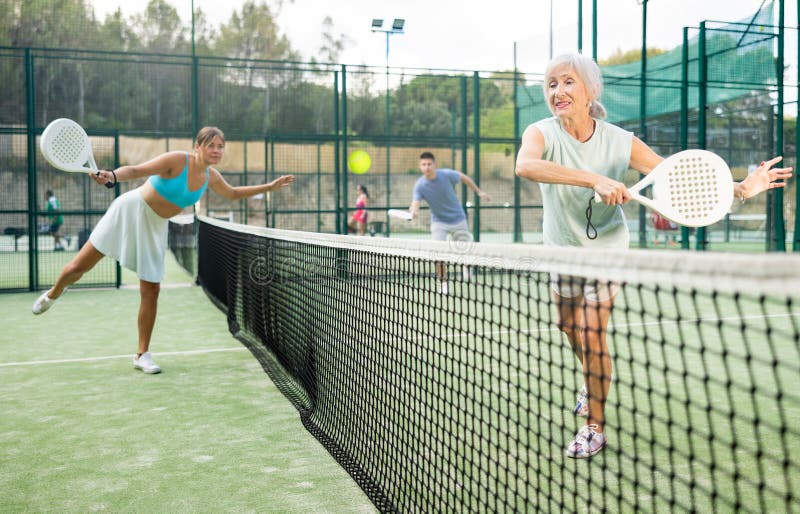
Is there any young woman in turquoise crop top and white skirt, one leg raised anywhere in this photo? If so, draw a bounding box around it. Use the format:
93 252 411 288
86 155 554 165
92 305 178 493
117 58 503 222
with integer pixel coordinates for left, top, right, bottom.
33 127 294 373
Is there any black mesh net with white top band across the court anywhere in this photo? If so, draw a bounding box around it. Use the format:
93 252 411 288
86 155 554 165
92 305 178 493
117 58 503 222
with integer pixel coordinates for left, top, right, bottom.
189 214 800 512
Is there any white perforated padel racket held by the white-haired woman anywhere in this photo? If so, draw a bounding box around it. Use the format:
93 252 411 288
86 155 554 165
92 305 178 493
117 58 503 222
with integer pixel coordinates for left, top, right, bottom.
594 150 733 227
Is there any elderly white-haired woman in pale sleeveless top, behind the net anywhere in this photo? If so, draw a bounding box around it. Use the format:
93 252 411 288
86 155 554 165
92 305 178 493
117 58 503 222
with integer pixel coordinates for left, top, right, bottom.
516 54 792 458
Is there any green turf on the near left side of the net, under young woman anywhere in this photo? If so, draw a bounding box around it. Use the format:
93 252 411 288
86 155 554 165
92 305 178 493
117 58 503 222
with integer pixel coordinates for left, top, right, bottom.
0 254 375 513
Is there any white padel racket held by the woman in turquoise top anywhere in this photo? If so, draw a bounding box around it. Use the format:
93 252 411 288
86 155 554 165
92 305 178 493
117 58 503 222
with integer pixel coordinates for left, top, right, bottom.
40 118 114 188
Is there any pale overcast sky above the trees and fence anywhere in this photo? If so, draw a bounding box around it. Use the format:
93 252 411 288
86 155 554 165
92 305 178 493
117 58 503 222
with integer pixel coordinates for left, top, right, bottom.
89 0 780 72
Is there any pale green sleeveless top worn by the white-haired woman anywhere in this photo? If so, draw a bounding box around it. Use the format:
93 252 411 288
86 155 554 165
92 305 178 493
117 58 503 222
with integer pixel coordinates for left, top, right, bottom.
535 118 633 248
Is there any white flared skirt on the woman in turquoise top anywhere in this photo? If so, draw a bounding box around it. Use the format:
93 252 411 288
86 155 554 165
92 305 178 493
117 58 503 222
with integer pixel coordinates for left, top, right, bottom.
89 188 169 282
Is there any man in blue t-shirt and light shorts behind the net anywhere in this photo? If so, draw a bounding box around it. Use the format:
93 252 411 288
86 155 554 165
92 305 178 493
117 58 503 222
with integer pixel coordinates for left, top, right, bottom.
409 152 490 294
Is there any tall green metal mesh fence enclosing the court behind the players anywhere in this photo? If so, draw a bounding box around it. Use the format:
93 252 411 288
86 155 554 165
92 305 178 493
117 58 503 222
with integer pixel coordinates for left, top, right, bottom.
0 1 800 290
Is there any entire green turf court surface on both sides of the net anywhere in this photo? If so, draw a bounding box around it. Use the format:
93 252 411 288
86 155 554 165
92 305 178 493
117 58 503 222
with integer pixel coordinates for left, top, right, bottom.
0 247 800 513
